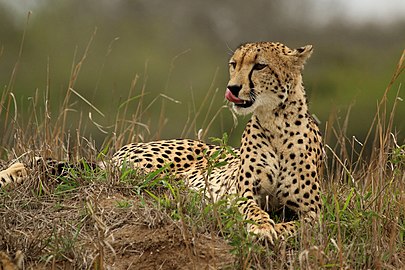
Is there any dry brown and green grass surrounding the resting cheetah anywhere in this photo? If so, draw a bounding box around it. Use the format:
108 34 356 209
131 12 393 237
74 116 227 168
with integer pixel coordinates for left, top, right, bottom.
0 24 405 269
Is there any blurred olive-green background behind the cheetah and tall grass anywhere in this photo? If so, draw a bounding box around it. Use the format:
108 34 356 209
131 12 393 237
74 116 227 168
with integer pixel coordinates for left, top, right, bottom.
0 0 405 150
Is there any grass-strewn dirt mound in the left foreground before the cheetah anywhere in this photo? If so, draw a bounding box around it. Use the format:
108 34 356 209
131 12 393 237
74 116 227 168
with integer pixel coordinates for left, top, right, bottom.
0 171 234 270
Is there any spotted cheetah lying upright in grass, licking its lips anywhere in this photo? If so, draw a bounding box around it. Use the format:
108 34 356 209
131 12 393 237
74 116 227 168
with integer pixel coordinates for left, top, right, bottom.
0 42 323 243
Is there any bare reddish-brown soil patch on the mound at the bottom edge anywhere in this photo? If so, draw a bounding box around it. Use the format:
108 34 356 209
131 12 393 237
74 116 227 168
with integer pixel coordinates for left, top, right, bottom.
96 193 233 269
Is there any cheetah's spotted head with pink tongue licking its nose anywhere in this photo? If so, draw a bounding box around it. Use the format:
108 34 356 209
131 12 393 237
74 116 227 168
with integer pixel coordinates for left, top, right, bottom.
225 42 312 114
